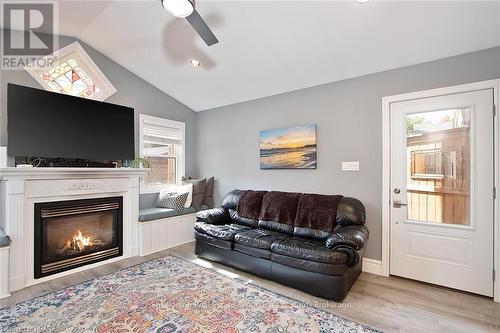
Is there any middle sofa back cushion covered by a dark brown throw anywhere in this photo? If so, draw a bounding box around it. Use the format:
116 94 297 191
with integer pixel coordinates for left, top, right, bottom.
259 191 300 235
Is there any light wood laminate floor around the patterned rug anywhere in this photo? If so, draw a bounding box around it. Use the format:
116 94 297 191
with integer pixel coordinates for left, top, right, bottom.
0 243 500 333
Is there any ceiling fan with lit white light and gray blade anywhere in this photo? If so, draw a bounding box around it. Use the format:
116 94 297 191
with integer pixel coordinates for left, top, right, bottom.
161 0 219 46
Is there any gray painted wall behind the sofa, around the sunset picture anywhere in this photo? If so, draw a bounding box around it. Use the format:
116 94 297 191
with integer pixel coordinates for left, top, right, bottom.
195 47 500 259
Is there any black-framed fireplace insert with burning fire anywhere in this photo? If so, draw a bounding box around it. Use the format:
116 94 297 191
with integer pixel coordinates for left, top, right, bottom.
34 197 123 278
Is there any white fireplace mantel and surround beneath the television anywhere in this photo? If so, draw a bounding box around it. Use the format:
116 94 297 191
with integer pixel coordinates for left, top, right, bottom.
0 168 147 291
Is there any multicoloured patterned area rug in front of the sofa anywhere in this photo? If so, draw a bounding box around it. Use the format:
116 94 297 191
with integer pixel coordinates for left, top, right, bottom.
0 256 376 333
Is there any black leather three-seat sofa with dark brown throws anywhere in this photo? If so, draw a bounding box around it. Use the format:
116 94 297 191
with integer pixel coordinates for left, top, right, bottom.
195 190 369 301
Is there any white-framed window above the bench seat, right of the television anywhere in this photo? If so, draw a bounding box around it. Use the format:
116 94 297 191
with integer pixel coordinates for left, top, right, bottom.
139 114 185 193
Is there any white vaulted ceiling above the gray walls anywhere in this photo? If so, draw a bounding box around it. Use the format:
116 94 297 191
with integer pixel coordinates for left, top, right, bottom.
32 0 500 111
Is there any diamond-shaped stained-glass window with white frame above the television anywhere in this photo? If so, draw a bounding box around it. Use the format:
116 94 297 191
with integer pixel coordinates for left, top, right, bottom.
25 42 116 101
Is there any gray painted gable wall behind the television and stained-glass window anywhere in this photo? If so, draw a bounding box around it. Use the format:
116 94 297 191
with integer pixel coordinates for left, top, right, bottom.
0 32 196 176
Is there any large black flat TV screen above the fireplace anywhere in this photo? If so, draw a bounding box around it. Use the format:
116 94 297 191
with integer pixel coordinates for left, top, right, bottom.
7 84 135 161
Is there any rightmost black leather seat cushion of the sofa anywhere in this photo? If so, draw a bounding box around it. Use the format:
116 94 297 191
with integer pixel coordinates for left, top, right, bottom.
271 237 349 265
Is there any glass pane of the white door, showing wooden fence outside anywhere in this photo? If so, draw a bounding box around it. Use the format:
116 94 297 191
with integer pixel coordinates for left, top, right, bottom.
406 108 470 225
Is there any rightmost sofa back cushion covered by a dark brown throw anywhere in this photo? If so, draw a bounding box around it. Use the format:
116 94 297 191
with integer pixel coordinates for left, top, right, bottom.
293 194 342 240
